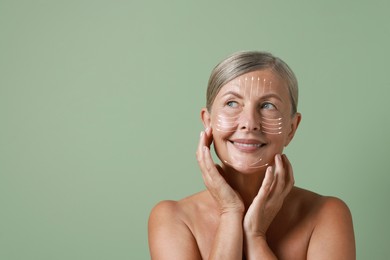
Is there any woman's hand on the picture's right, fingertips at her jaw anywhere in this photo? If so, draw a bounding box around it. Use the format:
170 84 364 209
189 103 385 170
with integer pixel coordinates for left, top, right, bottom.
243 154 294 240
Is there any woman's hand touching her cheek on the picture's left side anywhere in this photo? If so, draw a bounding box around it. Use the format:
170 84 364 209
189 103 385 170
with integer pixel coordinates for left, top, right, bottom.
196 128 245 214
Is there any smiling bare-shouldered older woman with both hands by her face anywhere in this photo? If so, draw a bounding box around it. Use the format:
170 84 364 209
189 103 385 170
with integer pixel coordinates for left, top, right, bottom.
149 52 355 260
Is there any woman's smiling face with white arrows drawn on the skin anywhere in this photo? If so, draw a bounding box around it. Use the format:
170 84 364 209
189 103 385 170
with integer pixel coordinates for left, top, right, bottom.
202 70 300 173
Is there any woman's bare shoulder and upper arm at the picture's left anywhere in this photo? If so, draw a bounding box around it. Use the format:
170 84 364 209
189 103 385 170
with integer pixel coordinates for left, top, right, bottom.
148 192 207 259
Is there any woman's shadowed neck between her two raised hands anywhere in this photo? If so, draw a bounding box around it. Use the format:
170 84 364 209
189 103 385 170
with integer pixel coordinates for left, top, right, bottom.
222 165 266 210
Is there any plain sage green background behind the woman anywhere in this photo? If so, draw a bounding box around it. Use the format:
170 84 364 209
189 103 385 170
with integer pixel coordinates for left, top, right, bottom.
0 0 390 260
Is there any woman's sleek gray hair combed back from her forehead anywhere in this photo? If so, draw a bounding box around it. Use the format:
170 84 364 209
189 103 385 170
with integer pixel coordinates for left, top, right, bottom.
206 51 298 115
